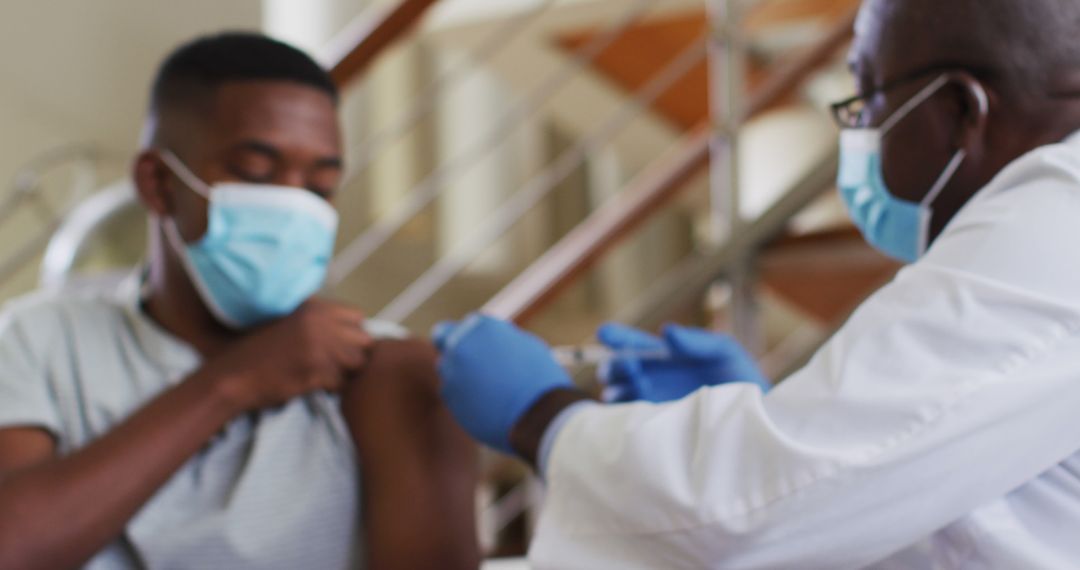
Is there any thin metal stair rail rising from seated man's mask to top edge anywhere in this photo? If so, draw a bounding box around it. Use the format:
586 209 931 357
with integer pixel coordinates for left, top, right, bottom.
327 0 654 287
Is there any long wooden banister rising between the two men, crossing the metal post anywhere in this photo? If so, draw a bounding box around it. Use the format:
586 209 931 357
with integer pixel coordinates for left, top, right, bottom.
484 12 855 324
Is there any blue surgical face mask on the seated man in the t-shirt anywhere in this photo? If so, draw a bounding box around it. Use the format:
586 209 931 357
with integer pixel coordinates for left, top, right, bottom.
162 150 338 329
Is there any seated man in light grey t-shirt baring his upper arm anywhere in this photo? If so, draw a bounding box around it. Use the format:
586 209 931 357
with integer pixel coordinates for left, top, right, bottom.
0 33 477 570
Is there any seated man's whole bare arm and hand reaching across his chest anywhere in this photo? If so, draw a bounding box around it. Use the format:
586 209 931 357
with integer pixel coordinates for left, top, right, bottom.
0 301 373 569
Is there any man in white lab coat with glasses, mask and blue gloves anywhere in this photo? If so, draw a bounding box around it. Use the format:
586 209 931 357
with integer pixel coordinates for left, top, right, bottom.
437 0 1080 569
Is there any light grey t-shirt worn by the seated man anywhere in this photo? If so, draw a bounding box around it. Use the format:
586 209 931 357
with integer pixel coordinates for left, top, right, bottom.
0 283 361 570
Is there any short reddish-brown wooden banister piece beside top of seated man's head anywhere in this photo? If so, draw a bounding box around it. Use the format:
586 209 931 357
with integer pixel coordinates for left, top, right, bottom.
327 0 437 87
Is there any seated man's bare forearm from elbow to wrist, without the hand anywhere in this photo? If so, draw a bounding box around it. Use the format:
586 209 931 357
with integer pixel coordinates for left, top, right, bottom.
0 372 245 569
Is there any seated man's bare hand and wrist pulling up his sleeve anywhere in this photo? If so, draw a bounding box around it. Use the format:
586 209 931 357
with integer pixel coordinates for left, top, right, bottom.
202 300 372 411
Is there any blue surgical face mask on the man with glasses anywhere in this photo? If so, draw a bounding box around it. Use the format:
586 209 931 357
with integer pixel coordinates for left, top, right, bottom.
837 76 985 263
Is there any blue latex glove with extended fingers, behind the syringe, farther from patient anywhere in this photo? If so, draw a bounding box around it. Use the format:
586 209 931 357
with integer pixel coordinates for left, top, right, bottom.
596 324 771 402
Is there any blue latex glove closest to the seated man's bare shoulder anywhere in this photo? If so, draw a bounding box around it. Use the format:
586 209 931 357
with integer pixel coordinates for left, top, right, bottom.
432 314 572 453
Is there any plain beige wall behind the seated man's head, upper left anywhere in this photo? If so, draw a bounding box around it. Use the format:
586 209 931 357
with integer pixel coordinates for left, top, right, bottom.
0 0 261 299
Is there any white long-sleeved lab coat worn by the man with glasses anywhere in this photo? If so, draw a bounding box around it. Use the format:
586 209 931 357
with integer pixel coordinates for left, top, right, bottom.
530 136 1080 570
